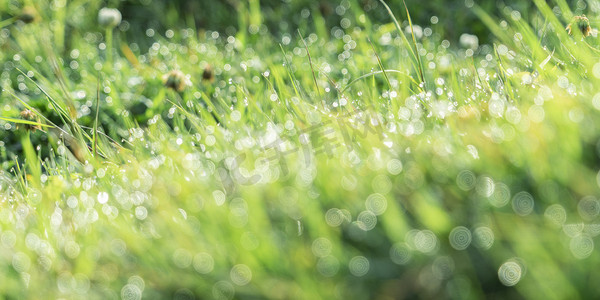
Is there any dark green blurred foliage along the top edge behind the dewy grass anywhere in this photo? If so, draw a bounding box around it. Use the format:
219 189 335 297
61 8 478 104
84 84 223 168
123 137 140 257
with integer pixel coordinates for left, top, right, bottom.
0 0 599 46
